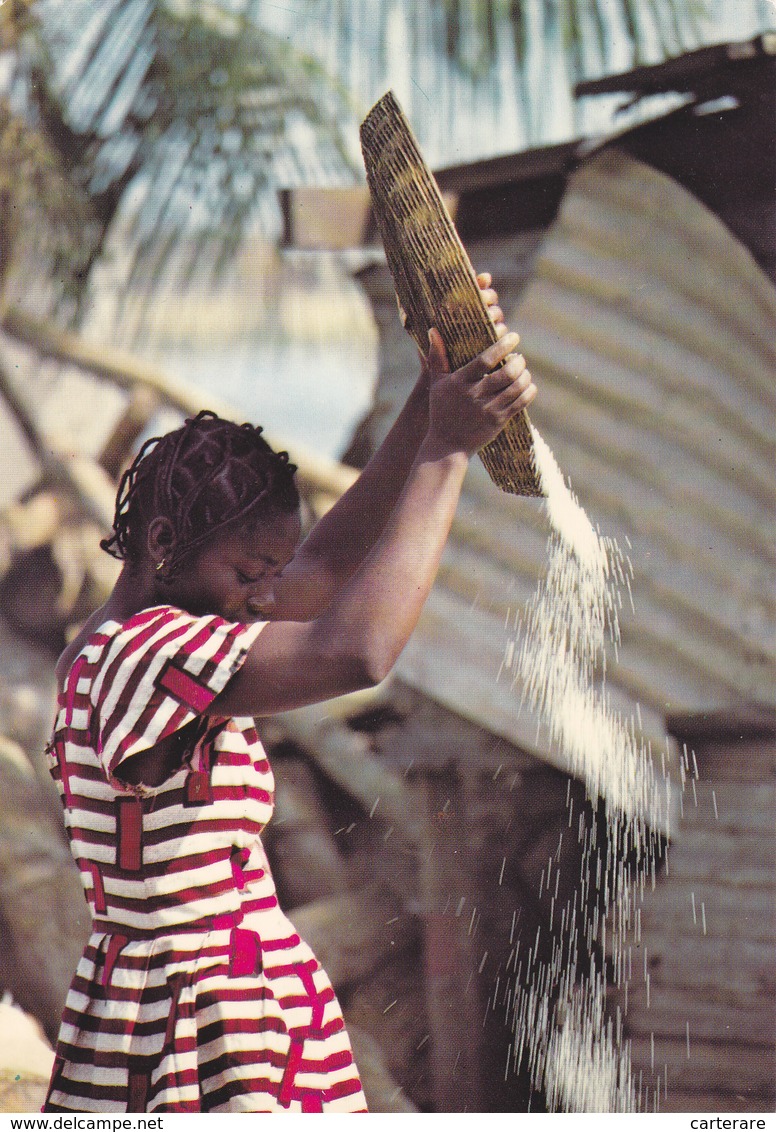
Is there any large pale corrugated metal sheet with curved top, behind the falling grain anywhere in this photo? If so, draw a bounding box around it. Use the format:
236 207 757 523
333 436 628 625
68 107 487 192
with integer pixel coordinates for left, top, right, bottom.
398 148 776 761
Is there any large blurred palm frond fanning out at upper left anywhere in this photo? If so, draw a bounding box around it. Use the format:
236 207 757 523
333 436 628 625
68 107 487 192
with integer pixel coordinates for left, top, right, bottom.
20 0 351 305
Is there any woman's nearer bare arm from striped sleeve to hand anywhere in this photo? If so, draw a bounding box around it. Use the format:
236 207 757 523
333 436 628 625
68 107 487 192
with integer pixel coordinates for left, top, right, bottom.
216 332 536 715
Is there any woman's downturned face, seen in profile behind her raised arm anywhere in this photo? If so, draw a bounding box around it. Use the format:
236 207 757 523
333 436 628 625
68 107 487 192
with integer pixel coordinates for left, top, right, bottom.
159 512 301 621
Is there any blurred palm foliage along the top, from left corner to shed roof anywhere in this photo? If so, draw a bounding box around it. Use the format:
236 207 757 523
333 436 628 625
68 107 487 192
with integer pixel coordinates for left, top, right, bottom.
0 0 708 323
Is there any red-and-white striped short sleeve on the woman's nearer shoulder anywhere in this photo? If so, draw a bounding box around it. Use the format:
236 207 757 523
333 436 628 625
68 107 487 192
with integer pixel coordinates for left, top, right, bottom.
90 606 266 789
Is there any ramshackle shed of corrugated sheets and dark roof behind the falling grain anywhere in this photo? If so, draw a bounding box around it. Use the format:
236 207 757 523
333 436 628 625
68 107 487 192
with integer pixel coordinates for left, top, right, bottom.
278 35 776 1110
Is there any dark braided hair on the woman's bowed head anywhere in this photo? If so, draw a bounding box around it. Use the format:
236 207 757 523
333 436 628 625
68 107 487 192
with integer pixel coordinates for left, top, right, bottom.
100 410 300 576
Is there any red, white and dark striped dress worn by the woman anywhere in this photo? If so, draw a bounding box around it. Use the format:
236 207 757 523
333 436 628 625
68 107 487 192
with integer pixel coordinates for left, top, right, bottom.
44 606 367 1113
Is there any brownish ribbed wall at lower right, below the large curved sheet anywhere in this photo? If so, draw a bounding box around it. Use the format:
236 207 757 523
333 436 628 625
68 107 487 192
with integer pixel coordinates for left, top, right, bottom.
628 720 776 1113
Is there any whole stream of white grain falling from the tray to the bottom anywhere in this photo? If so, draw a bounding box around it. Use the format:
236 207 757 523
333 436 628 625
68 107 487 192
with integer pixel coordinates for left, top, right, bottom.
502 426 669 1113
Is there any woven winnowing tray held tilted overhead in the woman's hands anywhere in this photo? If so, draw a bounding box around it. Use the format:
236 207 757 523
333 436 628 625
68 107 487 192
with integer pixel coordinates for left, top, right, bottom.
361 91 543 496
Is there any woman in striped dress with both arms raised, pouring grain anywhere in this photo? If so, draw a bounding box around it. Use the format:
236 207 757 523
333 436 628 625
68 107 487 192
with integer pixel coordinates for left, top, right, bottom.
44 276 536 1113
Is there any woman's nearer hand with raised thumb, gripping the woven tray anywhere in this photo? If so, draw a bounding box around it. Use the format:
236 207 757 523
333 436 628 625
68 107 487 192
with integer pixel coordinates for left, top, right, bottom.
428 327 536 455
